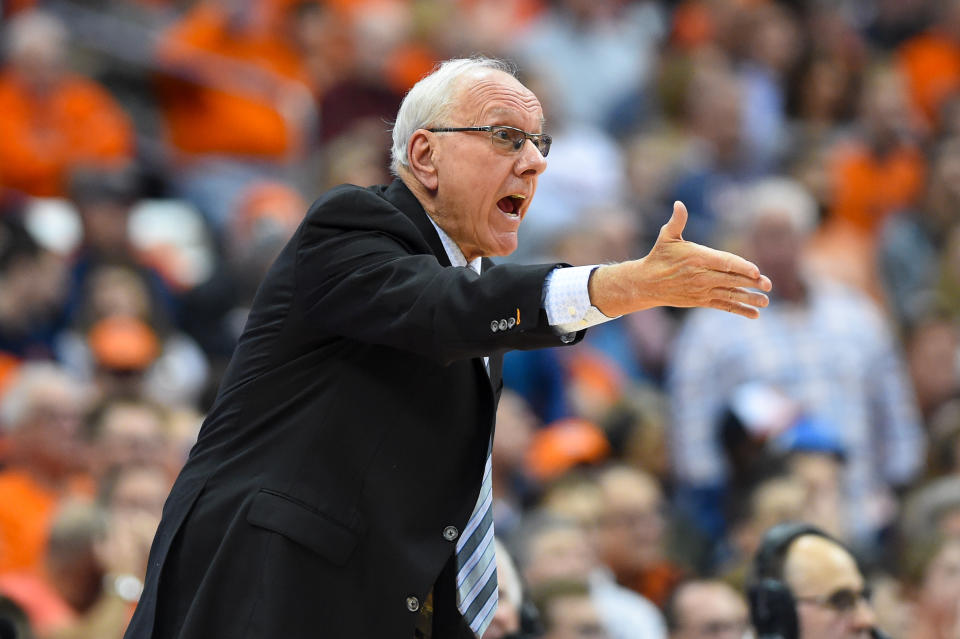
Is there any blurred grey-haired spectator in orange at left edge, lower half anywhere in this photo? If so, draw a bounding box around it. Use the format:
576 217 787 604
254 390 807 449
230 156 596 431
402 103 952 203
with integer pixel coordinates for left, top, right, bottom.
0 363 92 574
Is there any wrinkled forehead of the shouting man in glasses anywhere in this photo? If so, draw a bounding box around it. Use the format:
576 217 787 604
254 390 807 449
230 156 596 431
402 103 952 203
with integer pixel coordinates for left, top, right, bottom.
453 69 543 131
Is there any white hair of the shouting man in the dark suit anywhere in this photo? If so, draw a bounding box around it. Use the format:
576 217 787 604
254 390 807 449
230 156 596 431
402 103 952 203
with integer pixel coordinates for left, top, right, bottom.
390 56 516 175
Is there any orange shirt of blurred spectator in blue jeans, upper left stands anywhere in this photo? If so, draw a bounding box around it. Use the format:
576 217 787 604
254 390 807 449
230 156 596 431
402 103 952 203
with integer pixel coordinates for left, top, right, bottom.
159 4 312 159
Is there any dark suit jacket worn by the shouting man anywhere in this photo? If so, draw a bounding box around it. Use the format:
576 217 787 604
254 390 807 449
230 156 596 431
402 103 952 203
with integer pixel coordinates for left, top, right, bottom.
126 181 580 639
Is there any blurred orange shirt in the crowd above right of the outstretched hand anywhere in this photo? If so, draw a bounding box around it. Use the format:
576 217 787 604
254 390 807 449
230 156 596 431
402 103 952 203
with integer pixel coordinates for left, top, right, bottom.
831 141 926 235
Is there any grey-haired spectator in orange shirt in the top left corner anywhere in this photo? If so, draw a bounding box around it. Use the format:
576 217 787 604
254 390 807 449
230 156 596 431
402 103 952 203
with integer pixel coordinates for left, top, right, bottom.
0 11 133 197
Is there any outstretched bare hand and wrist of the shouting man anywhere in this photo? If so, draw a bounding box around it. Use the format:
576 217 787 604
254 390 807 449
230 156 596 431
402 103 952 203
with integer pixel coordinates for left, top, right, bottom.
590 201 771 318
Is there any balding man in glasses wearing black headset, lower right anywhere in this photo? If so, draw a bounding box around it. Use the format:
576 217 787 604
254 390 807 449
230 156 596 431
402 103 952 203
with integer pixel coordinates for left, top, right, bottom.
747 523 888 639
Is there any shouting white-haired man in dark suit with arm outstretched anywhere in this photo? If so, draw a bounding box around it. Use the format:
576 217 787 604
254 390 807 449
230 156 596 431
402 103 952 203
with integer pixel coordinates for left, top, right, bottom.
127 59 770 639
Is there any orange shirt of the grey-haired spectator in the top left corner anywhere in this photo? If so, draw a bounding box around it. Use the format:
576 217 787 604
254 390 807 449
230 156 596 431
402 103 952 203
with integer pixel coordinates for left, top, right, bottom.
0 71 133 196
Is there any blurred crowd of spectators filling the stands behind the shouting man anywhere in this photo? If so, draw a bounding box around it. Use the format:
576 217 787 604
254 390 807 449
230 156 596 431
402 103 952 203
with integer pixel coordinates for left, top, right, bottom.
0 0 960 639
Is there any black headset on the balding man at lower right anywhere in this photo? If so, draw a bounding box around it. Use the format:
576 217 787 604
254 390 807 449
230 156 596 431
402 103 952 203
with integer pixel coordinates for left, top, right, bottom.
747 522 890 639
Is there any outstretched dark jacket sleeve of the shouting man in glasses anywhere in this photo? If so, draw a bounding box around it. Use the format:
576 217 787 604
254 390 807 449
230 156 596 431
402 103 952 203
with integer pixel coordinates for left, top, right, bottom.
295 186 582 364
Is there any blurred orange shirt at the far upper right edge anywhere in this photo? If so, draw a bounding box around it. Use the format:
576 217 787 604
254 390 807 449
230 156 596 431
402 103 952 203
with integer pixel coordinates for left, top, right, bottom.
897 32 960 122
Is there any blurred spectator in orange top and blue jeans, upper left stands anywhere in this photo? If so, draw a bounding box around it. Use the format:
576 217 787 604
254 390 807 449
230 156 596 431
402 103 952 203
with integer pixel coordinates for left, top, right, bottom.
158 0 315 229
